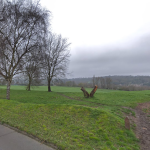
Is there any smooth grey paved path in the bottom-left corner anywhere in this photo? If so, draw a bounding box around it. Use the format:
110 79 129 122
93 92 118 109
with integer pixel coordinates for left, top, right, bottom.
0 125 54 150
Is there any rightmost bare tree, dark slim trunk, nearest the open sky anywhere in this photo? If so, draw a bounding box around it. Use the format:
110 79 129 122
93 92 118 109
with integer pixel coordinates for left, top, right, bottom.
43 34 70 92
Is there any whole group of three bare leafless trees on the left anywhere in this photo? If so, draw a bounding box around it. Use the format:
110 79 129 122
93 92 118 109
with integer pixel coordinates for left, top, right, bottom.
0 0 70 99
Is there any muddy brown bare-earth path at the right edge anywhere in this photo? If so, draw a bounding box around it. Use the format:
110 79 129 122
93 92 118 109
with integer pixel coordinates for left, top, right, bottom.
134 102 150 150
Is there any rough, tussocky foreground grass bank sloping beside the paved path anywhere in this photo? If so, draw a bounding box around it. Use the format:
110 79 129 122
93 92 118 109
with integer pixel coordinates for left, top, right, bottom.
0 100 139 150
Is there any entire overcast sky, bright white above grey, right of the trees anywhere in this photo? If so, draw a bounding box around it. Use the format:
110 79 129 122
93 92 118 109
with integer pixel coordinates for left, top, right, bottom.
41 0 150 78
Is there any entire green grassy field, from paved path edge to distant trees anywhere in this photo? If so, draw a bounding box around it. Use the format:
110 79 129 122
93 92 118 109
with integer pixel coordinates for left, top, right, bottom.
0 86 150 150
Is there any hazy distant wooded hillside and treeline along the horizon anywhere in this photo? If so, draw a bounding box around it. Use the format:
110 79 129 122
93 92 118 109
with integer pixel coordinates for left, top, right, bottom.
54 76 150 91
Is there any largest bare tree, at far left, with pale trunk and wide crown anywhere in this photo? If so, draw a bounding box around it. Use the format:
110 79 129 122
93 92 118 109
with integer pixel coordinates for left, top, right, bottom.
0 0 49 99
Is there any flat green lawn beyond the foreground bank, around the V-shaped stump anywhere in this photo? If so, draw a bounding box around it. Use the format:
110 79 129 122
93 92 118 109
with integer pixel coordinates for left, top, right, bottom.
0 86 150 108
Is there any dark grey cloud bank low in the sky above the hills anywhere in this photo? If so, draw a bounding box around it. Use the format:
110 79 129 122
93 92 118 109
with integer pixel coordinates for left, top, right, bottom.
69 35 150 77
